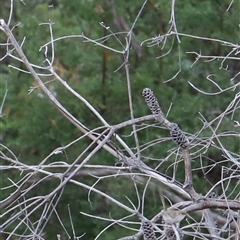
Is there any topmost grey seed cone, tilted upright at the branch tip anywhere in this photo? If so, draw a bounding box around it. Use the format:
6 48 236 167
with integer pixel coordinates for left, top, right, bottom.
142 88 164 123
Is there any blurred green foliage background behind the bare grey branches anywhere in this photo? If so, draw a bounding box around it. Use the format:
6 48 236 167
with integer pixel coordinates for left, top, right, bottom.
0 0 240 240
